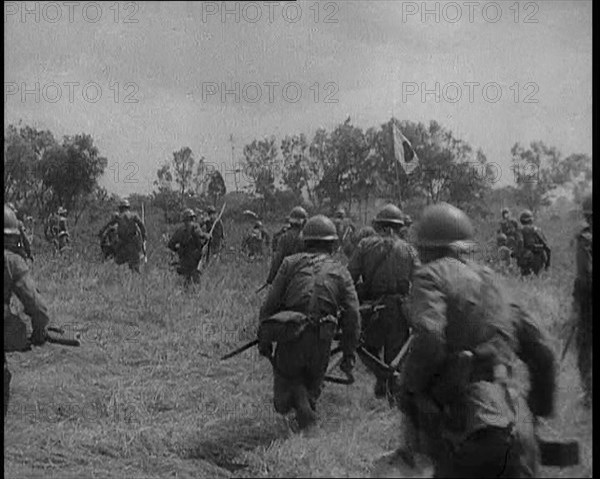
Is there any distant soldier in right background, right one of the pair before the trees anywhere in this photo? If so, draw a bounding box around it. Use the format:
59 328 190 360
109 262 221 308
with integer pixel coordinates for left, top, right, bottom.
518 210 550 276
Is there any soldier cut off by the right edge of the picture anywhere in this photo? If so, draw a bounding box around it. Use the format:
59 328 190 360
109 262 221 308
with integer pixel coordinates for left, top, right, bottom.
573 195 593 408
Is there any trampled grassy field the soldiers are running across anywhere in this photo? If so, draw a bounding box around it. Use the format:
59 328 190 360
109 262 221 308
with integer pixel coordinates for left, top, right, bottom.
4 212 592 478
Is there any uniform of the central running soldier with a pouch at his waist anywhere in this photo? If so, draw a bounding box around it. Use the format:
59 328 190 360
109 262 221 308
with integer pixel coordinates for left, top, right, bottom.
259 253 360 427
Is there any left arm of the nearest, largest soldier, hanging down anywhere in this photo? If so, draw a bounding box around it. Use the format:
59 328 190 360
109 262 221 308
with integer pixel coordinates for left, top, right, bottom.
404 268 447 394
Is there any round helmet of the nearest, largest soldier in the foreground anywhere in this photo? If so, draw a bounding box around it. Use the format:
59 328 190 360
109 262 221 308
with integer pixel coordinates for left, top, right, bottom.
417 203 474 250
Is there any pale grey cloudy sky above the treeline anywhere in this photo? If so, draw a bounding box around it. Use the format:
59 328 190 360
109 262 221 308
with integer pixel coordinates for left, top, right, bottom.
4 0 592 195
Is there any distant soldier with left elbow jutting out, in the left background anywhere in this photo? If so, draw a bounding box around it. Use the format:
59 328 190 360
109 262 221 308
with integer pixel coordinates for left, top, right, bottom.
98 200 146 273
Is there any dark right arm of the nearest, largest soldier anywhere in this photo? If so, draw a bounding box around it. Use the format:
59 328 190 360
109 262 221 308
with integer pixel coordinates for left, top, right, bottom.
511 303 556 417
